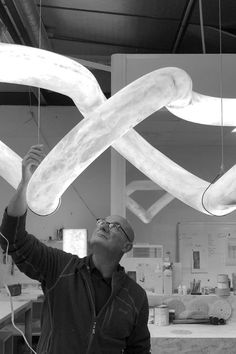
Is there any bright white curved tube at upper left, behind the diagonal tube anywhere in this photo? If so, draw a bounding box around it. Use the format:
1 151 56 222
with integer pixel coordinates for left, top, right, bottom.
0 43 106 116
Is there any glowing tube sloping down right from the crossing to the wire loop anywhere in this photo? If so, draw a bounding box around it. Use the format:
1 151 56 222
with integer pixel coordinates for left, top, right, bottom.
112 130 236 216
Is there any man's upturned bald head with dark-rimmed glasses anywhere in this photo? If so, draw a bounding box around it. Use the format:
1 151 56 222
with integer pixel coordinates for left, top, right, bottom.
90 215 131 253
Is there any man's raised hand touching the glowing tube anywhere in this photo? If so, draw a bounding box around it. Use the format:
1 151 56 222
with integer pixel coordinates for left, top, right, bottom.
21 145 45 186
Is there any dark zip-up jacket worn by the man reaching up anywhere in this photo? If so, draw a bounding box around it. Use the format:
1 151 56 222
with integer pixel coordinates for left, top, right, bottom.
0 212 150 354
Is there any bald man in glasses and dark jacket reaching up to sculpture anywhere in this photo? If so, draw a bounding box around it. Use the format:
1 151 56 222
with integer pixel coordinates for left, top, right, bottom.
0 145 150 354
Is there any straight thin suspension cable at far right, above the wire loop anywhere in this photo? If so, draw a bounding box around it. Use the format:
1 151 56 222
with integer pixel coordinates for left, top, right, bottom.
219 0 224 173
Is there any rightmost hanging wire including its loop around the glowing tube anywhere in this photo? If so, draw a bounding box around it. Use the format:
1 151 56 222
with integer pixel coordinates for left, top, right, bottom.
199 0 224 216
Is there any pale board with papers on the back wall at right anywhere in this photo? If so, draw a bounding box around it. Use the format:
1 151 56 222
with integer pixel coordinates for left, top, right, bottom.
178 222 236 288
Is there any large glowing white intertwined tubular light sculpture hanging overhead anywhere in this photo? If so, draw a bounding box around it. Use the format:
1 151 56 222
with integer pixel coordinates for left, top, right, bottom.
0 44 236 215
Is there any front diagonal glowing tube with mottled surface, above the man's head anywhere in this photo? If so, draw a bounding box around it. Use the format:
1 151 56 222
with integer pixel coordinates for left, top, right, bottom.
25 68 191 215
